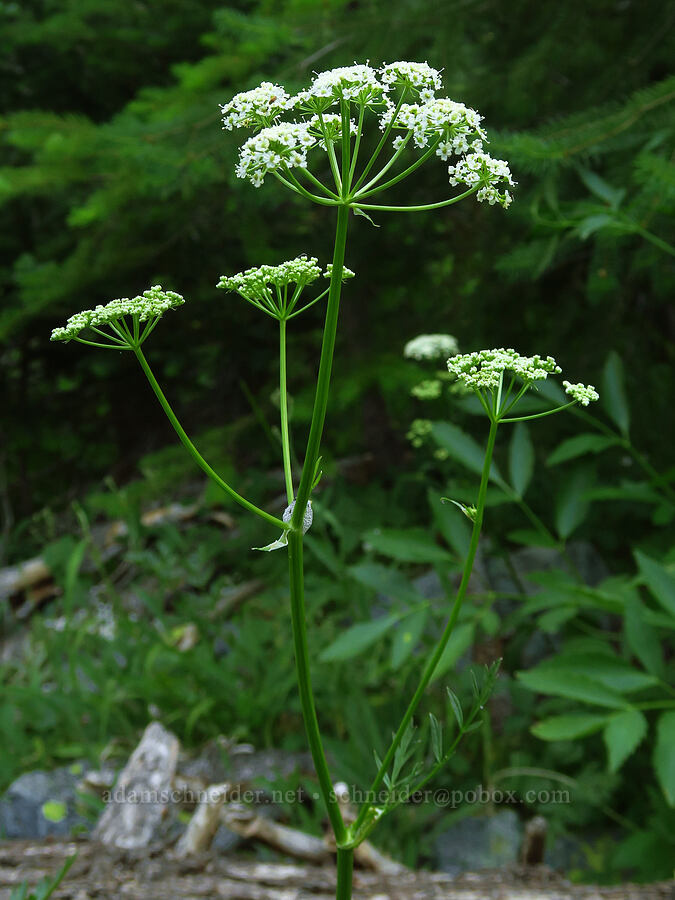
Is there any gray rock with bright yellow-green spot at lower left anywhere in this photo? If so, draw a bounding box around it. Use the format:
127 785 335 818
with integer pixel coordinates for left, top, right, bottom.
0 766 91 840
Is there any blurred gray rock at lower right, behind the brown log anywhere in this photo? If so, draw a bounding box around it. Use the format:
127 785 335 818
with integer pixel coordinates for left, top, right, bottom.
435 809 522 875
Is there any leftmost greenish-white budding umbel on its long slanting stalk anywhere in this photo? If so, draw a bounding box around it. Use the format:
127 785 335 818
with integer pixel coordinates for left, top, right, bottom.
51 285 185 349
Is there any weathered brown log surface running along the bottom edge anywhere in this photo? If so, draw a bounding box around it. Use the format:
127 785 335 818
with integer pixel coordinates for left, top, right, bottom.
0 840 675 900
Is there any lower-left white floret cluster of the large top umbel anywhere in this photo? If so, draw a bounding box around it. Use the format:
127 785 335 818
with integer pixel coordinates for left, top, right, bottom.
235 122 316 187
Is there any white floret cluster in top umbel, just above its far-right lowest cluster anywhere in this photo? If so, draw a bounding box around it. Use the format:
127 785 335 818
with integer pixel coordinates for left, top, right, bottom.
380 97 486 160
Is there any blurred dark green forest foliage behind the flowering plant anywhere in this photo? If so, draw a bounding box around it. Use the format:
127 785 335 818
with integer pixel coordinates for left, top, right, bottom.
0 0 675 880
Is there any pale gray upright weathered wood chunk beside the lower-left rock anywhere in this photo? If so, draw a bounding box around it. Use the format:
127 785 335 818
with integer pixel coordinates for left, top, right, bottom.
94 722 178 849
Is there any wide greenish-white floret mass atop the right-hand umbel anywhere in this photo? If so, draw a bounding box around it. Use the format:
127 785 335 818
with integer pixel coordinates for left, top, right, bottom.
448 347 562 391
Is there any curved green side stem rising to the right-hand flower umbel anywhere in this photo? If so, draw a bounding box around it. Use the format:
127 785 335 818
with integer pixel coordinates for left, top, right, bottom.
351 418 498 840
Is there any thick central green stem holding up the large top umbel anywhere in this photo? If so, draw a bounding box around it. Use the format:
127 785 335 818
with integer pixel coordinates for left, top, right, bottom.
288 205 351 848
